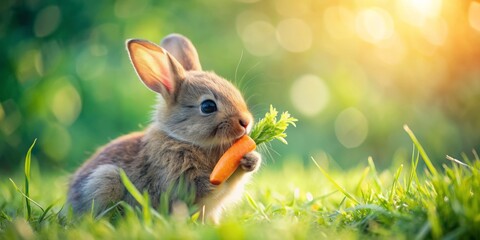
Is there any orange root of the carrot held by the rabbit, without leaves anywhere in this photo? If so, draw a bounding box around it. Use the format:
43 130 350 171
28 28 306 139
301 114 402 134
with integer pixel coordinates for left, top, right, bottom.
210 135 257 185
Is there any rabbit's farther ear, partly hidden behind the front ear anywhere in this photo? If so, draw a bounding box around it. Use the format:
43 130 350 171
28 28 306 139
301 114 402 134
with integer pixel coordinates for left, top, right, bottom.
160 33 202 71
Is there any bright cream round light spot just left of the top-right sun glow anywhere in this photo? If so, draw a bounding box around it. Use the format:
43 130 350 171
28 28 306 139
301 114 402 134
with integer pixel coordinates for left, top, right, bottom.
356 8 394 44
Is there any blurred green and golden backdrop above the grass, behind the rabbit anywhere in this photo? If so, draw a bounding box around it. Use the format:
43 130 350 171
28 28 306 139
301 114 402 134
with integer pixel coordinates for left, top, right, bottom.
0 0 480 172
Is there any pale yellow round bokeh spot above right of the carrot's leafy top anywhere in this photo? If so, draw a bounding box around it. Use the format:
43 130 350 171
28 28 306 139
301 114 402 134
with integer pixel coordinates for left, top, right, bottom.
290 74 330 116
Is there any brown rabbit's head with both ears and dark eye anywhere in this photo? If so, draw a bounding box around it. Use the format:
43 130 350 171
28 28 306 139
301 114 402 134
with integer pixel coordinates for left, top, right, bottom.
127 34 253 147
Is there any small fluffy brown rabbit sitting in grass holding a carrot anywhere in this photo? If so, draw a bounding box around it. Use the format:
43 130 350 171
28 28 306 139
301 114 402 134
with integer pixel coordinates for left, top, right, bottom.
68 34 261 222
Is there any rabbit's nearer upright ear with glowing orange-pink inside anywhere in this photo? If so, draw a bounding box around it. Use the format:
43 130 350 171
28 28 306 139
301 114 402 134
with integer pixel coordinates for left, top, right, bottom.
127 39 185 100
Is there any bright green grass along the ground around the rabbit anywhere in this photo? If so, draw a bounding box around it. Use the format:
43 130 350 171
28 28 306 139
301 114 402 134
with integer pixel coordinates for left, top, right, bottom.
0 128 480 239
